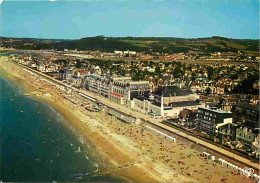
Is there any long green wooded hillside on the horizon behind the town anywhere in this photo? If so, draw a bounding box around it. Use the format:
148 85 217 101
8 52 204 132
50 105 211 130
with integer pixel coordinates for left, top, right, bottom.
1 36 259 55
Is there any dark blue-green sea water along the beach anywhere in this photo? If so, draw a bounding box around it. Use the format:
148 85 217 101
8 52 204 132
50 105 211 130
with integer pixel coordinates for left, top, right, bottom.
0 75 122 182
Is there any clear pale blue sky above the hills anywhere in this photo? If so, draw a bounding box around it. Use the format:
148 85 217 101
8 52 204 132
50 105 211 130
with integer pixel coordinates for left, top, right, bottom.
0 0 259 39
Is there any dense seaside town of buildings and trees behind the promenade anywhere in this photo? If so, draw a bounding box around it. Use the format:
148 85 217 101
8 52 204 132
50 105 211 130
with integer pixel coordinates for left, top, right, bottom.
7 39 260 162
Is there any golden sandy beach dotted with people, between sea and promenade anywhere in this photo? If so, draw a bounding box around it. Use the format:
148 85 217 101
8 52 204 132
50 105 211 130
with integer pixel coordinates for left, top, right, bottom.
0 57 255 183
